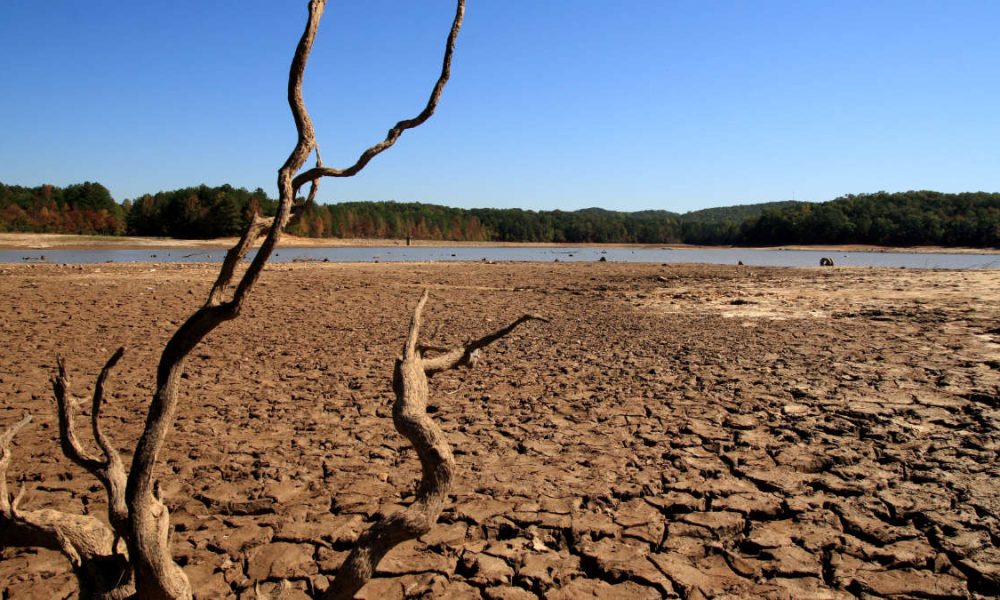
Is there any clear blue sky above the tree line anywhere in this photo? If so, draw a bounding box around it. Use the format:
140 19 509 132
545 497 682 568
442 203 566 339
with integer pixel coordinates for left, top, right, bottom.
0 0 1000 212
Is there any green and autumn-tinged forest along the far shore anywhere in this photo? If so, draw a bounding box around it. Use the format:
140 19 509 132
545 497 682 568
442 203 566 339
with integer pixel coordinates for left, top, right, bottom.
0 182 1000 248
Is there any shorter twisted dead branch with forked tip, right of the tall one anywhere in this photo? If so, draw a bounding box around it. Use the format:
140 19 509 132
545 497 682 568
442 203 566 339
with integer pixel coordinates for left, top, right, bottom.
323 290 547 600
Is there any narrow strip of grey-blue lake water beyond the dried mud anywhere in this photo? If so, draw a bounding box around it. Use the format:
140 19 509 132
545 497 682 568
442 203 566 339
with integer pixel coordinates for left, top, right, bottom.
0 246 1000 269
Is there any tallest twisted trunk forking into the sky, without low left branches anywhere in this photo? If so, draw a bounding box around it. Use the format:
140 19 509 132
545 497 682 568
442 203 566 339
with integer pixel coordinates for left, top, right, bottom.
125 0 465 600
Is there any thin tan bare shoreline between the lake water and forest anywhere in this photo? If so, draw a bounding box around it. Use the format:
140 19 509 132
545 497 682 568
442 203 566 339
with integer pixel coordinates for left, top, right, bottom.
0 233 1000 254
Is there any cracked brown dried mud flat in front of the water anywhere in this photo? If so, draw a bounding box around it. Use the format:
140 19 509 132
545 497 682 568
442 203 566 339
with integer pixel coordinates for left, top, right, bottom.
0 263 1000 599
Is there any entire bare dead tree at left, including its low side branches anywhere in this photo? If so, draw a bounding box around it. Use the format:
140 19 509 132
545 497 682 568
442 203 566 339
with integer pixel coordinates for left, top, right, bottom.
0 0 484 600
